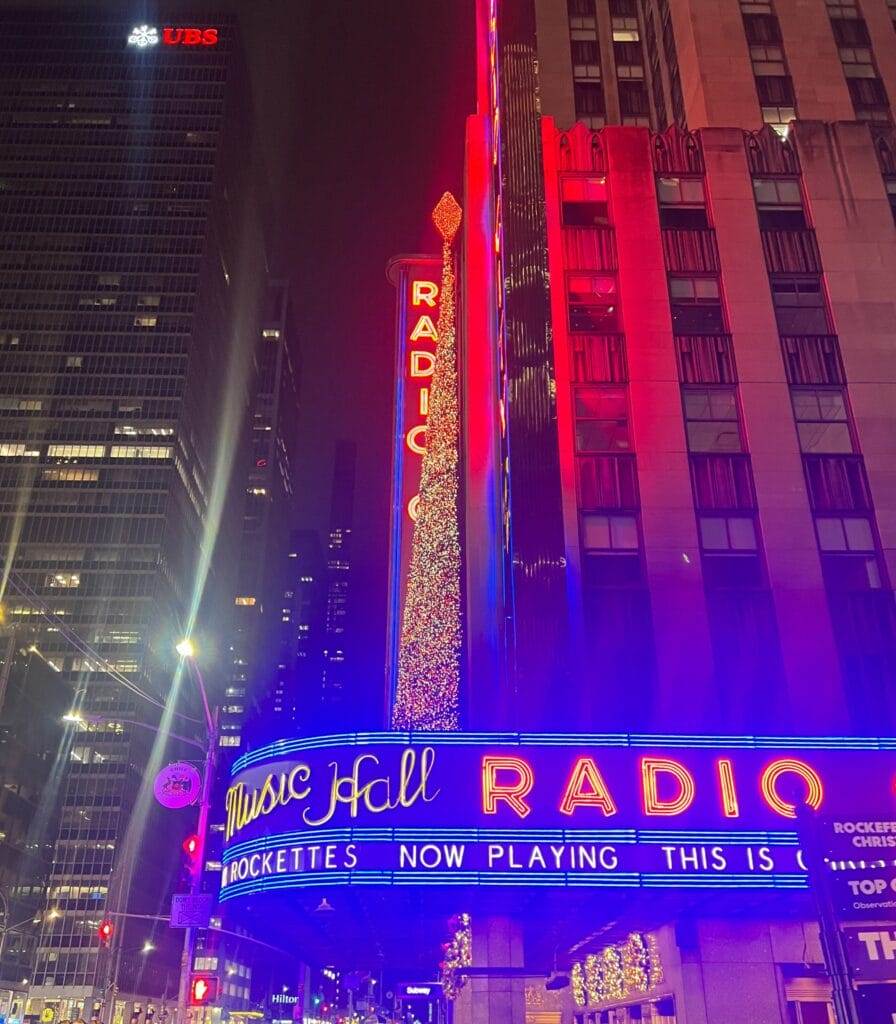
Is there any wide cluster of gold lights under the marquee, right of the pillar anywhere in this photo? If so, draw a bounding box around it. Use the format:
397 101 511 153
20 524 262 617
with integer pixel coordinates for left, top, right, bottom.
569 932 663 1007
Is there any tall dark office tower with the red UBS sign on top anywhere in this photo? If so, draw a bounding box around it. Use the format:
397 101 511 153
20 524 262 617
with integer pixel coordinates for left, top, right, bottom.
0 8 264 1019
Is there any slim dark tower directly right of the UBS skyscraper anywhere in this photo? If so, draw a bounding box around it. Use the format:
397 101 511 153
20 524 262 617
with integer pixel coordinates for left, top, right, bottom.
219 281 299 755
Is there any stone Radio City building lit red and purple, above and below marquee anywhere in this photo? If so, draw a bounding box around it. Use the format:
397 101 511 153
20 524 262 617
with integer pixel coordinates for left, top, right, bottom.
456 0 896 1024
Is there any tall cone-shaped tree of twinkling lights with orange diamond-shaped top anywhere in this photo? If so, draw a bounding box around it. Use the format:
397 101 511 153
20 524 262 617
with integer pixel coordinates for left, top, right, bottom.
392 193 462 731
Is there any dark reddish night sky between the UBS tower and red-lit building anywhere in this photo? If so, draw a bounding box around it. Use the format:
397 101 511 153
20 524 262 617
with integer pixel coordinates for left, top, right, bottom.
274 0 474 714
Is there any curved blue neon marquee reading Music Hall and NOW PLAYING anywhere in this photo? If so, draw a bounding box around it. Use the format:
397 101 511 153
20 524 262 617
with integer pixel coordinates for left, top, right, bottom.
220 732 896 899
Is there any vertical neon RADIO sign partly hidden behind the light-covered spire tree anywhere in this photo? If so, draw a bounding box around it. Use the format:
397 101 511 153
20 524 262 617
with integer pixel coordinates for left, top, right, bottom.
386 256 441 707
